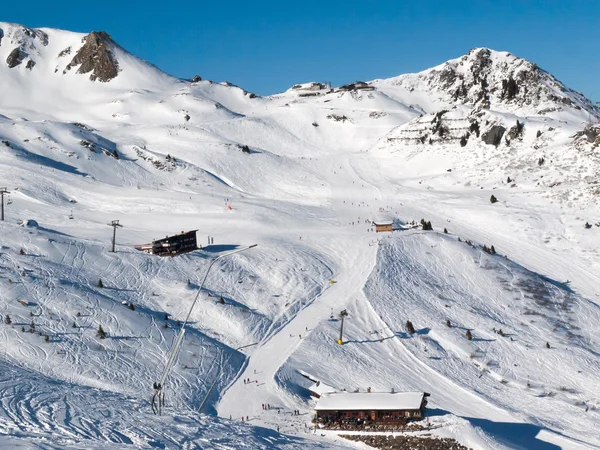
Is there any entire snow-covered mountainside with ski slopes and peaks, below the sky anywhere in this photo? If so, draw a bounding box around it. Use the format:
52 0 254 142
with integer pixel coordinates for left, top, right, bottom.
0 23 600 449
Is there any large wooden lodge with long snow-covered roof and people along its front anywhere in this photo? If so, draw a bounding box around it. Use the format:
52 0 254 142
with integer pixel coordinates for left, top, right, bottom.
315 392 429 428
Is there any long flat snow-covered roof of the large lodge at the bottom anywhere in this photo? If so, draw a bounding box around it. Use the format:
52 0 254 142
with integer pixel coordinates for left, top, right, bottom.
315 392 425 411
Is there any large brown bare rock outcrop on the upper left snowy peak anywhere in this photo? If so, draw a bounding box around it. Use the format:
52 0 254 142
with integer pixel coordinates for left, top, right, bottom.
63 31 119 83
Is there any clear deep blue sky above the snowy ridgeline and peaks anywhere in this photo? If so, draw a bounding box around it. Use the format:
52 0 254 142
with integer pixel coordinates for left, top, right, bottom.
0 0 600 101
